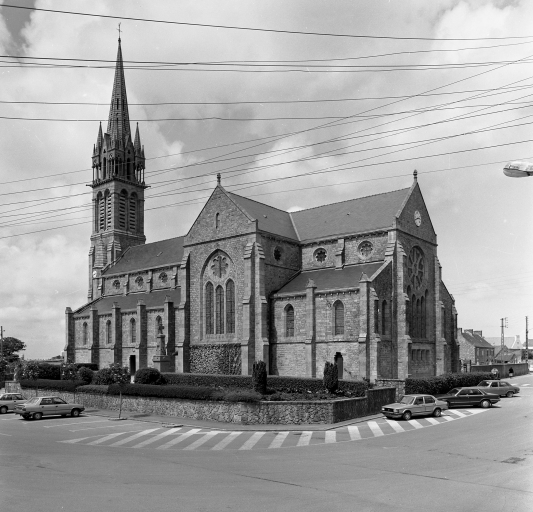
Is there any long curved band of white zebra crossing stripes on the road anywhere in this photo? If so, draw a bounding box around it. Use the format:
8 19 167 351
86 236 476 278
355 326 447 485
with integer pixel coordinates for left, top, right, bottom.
58 409 487 451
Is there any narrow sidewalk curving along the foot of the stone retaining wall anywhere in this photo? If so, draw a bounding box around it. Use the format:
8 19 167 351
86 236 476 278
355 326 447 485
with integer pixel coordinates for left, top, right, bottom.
83 409 383 432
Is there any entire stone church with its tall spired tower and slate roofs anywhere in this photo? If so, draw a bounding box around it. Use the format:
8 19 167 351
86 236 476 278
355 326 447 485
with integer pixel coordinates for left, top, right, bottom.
64 40 458 382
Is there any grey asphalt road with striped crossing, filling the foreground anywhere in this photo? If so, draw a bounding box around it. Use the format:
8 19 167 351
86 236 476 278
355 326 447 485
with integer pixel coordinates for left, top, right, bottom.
0 375 533 512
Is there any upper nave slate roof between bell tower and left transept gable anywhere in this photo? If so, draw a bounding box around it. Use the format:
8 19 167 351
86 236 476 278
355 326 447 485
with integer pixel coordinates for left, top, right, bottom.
104 236 184 276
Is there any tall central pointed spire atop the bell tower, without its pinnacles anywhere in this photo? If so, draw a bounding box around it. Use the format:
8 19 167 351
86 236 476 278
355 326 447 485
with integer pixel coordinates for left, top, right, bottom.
107 39 131 148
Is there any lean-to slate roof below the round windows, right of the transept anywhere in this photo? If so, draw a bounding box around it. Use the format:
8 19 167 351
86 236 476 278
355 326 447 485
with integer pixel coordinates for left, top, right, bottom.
277 261 383 293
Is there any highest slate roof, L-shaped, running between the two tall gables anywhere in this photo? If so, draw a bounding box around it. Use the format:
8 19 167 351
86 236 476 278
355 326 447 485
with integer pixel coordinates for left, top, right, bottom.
226 188 411 242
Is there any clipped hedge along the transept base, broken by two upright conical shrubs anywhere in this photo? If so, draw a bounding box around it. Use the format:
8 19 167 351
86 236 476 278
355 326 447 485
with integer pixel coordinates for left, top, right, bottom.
162 373 370 397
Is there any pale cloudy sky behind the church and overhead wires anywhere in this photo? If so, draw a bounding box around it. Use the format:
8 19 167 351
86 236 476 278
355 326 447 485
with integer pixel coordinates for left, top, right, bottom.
0 0 533 358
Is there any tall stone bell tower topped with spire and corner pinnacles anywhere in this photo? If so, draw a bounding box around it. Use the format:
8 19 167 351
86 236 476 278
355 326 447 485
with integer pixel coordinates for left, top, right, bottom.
88 38 147 301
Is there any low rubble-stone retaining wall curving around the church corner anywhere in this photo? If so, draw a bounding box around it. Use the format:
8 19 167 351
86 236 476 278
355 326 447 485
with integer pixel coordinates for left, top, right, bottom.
20 388 396 425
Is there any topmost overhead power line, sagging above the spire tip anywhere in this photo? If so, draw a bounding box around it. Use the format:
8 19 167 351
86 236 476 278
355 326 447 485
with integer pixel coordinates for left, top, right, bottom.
0 4 533 41
